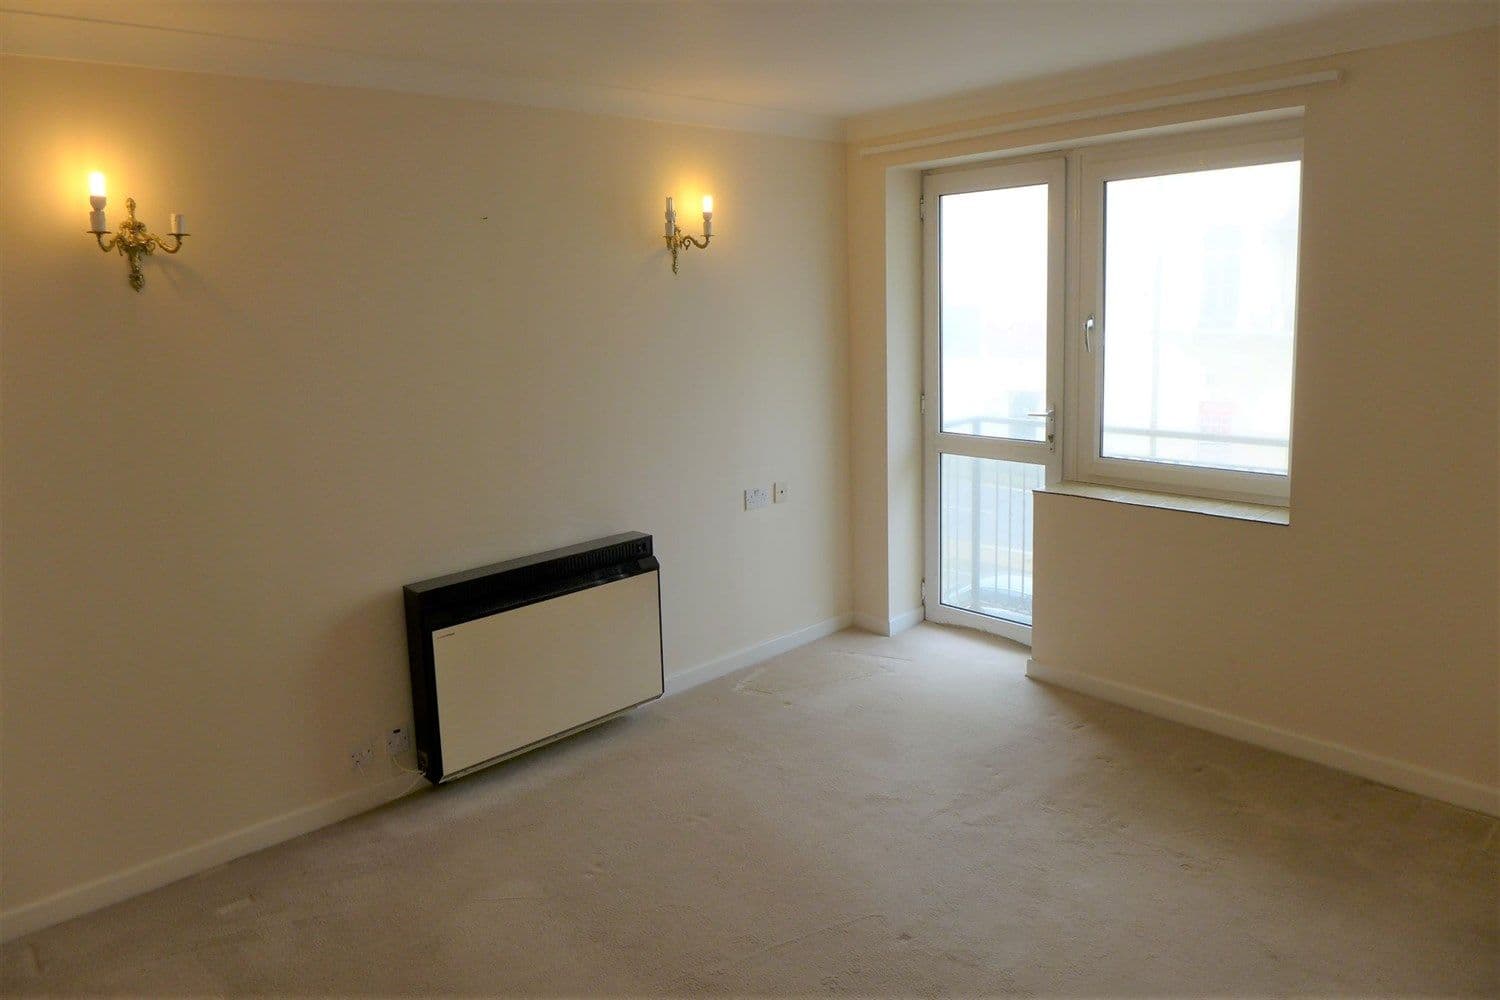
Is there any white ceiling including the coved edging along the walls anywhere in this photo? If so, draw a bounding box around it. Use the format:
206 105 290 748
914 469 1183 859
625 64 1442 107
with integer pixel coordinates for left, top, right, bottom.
0 0 1500 137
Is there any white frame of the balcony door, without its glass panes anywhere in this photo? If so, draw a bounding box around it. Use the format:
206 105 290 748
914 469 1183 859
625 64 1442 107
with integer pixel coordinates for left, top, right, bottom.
923 154 1068 646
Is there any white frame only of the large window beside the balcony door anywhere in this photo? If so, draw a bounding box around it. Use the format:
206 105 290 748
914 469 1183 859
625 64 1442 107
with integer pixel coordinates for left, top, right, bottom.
1064 120 1302 507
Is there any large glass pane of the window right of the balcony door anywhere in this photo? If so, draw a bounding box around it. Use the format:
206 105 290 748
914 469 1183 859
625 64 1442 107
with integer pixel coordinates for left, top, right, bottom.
1101 162 1301 475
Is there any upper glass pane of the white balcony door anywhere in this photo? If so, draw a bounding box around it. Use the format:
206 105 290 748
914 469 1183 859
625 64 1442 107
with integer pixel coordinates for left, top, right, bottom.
938 184 1047 441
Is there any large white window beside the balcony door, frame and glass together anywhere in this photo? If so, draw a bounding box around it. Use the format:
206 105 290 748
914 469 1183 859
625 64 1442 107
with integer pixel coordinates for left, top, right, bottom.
1070 135 1302 502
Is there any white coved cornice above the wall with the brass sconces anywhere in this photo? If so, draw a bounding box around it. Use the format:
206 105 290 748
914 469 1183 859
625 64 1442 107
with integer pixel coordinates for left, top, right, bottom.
0 7 843 142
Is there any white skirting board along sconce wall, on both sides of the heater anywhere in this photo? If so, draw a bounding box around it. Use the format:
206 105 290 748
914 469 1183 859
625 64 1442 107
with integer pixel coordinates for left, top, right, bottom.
0 615 854 942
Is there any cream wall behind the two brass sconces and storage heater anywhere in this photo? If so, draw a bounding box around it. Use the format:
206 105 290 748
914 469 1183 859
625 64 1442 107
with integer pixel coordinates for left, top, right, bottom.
0 58 851 912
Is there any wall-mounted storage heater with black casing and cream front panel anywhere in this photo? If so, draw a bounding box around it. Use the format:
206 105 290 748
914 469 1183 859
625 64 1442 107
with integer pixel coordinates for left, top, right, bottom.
405 532 665 784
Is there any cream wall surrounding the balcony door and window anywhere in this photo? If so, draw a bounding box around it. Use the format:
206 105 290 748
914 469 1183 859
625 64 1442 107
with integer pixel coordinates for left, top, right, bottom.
849 28 1500 810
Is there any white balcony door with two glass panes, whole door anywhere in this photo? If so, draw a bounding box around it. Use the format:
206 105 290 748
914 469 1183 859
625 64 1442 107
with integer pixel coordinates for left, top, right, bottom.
923 157 1067 645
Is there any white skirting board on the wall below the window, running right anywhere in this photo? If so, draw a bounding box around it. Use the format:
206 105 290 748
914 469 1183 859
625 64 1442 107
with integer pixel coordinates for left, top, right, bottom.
1026 660 1500 816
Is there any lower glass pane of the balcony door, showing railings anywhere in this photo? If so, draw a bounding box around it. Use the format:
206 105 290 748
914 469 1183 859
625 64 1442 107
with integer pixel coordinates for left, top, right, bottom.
939 454 1046 625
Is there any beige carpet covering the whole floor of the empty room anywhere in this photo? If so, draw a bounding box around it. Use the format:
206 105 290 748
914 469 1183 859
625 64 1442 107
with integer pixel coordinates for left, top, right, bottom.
3 625 1500 996
